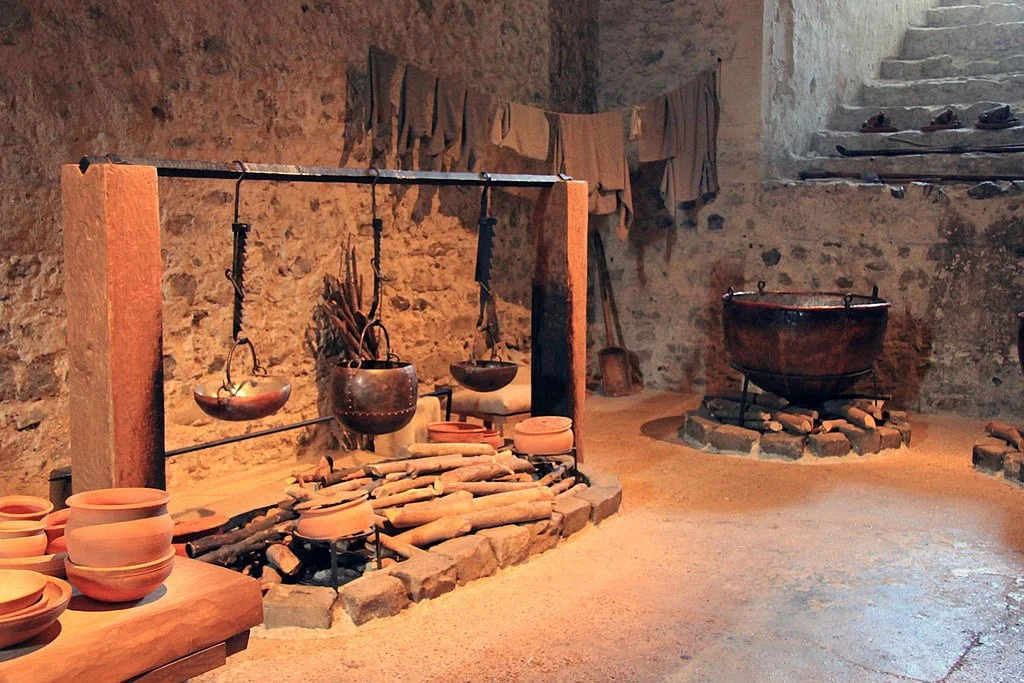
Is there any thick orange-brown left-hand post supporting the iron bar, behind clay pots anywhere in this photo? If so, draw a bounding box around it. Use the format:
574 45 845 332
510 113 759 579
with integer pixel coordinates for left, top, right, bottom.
60 164 165 492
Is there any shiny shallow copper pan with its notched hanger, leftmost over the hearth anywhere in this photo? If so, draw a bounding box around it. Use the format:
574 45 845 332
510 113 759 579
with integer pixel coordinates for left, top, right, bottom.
193 162 292 422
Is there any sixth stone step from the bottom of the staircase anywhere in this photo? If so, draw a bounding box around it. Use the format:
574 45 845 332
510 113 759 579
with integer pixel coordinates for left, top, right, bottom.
900 22 1024 59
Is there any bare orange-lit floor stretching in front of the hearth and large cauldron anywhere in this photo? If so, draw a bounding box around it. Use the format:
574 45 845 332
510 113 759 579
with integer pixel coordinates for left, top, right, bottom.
190 392 1024 683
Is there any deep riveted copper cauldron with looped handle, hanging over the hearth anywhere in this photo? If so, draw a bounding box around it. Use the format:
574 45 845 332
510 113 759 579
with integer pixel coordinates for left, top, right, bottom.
331 321 419 434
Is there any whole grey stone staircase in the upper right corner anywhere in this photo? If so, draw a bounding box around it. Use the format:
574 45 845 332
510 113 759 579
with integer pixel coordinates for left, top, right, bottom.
798 0 1024 176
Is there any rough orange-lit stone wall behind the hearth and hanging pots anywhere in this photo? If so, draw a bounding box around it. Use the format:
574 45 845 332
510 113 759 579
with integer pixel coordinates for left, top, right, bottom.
0 0 585 493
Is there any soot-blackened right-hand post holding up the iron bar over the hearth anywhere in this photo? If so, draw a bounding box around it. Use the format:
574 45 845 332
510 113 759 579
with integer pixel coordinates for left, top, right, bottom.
531 180 588 462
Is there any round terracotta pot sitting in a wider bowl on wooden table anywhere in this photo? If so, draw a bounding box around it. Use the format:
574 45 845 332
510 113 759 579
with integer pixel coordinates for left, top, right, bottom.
65 488 174 567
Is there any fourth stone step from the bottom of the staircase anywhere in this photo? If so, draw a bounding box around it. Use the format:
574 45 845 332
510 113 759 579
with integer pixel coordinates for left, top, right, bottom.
860 72 1024 106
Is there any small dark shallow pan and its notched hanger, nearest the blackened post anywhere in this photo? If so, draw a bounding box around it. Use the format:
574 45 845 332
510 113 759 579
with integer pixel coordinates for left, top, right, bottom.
449 173 519 392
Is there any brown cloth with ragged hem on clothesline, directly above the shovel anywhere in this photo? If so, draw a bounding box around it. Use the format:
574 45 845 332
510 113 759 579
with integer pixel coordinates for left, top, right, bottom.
554 112 633 241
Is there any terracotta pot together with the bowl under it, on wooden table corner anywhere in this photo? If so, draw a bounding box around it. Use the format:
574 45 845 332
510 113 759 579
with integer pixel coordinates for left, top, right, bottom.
65 488 174 602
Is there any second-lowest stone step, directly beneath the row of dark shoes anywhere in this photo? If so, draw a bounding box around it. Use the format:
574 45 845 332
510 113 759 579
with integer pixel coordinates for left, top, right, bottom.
811 126 1024 156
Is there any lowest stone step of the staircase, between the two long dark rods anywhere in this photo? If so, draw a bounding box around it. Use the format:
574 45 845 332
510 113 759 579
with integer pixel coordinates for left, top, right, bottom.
797 154 1024 177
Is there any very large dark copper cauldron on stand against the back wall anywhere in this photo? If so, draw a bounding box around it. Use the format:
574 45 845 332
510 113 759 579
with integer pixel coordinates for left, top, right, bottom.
722 283 892 403
